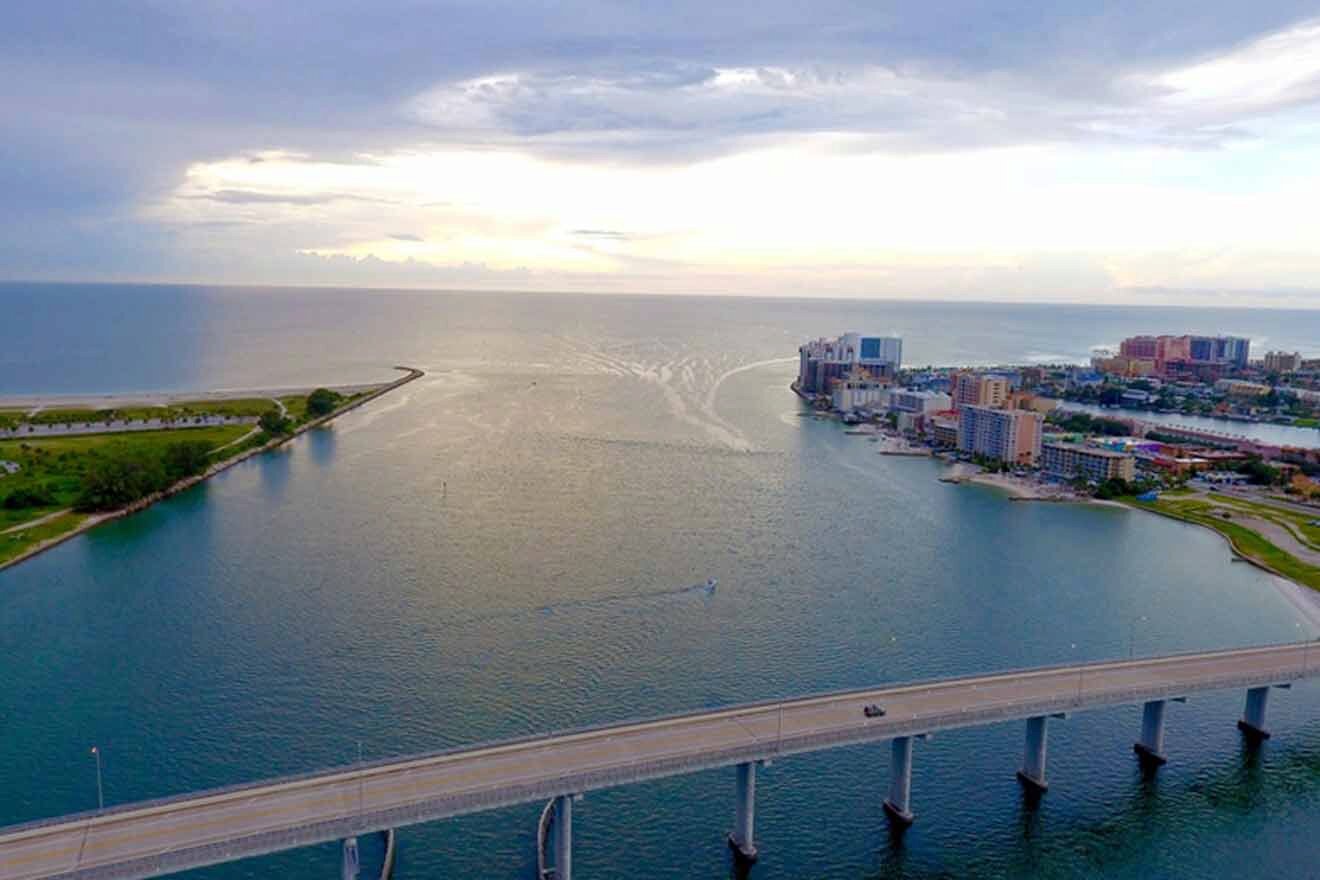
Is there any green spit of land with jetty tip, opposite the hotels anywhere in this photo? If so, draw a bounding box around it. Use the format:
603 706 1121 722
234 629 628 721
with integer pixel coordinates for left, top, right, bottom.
0 367 424 569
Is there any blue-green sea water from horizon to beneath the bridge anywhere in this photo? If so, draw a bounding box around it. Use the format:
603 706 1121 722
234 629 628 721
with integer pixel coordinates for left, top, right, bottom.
0 285 1320 879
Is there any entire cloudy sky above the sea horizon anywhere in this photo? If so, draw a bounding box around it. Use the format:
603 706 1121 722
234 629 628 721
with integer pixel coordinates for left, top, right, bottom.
0 0 1320 307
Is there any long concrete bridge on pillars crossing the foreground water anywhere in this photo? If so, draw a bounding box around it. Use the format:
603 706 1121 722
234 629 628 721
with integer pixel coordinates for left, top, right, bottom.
0 643 1320 880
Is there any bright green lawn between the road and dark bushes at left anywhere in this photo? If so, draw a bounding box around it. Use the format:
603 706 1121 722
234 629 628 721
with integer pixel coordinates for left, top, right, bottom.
0 425 251 537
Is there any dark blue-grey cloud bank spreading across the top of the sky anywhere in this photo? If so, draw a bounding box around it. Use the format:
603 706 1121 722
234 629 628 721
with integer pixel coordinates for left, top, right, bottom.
0 0 1315 274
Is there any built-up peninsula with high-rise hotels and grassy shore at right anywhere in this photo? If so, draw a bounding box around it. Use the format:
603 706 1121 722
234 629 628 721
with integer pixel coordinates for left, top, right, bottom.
792 332 1320 591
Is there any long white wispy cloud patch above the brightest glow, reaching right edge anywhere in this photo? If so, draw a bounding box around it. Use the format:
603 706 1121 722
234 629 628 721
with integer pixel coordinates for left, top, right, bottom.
404 22 1320 160
